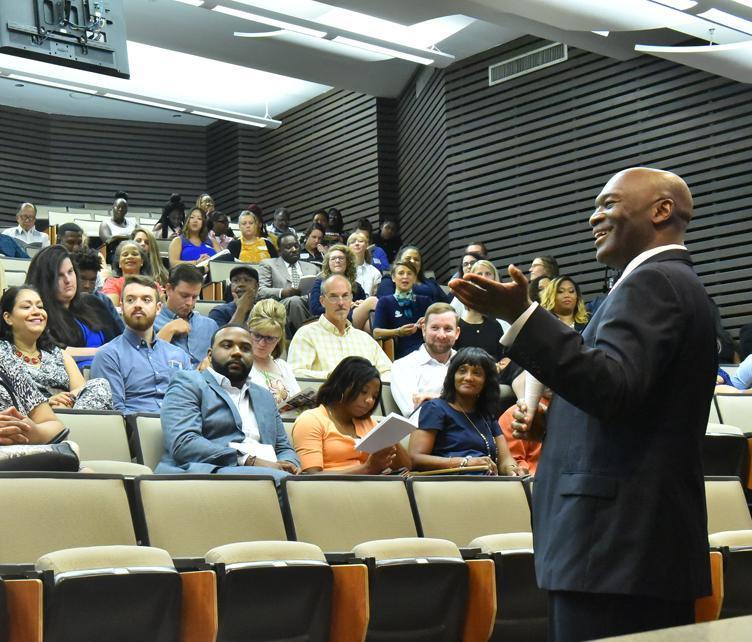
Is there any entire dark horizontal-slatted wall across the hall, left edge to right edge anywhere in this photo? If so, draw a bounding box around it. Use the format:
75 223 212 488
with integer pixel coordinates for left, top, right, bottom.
0 38 752 335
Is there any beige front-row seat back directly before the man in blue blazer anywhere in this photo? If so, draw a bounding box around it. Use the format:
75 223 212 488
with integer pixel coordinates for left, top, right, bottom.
135 475 287 558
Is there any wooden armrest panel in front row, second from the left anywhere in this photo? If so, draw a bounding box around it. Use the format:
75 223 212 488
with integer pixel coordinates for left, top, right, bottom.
180 571 219 642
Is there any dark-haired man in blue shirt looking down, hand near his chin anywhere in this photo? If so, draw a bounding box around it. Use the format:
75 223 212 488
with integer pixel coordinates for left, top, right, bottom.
154 264 217 368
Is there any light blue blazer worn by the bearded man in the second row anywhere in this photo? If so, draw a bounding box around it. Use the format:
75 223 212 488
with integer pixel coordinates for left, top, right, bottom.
155 370 300 474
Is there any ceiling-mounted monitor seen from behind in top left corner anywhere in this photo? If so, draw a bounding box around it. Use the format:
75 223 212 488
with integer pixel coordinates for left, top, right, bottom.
0 0 130 78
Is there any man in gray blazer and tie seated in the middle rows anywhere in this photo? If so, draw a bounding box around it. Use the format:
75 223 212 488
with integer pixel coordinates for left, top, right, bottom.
258 234 320 336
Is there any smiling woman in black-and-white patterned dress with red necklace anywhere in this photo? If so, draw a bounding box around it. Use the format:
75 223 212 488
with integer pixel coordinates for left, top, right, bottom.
0 285 112 410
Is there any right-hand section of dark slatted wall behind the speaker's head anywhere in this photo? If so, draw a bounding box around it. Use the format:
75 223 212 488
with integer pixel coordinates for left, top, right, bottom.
399 38 752 334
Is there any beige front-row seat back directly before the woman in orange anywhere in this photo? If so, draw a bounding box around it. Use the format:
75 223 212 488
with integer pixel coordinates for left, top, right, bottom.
282 475 417 552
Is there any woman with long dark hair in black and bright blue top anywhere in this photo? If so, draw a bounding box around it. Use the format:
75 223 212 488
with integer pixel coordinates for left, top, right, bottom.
26 245 120 369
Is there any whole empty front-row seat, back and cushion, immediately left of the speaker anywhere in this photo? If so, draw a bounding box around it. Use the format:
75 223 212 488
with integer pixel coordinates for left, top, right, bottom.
408 476 548 641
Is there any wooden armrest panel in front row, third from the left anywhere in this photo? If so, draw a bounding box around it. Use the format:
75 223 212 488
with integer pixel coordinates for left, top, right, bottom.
329 564 370 642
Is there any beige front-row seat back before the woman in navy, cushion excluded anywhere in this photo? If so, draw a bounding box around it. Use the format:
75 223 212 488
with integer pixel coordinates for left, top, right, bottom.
408 476 532 546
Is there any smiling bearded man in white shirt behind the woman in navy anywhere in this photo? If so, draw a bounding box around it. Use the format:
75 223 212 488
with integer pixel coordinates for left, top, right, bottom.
391 303 460 417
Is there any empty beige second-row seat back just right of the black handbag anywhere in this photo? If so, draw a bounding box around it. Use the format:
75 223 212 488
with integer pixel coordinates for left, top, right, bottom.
55 409 131 461
